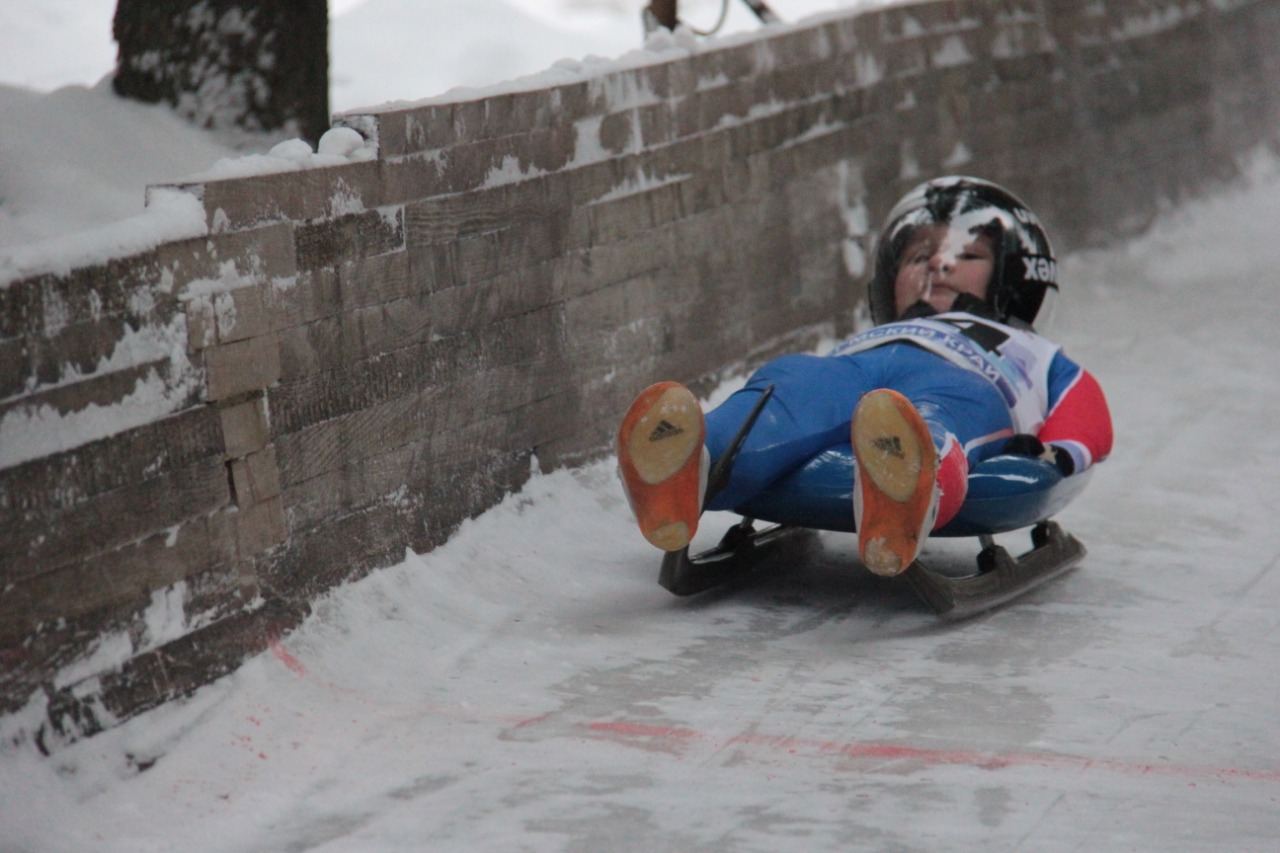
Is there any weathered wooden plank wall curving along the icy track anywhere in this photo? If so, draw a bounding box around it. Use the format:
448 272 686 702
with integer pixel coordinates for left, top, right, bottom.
0 0 1280 748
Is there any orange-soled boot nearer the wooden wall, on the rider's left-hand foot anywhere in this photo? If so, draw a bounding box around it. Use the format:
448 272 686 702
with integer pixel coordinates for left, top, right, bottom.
618 382 710 551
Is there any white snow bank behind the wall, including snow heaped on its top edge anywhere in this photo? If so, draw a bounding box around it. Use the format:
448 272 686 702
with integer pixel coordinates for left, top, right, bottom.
0 0 883 281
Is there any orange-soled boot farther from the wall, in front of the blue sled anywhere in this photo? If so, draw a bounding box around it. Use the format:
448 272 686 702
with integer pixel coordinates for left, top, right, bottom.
850 388 940 576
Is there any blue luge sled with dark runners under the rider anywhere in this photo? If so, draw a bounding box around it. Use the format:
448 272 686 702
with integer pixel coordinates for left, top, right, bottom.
658 391 1091 619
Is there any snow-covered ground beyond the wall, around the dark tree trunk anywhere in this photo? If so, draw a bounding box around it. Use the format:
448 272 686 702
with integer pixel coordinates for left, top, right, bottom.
0 0 870 252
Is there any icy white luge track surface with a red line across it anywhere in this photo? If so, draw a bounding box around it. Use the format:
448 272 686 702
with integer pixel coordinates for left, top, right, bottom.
0 0 1280 853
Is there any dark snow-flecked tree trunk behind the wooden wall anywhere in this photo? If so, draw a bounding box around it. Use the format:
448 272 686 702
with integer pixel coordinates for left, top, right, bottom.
113 0 329 142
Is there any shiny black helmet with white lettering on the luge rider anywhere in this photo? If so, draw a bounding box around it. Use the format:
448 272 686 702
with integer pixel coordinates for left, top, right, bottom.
868 175 1057 325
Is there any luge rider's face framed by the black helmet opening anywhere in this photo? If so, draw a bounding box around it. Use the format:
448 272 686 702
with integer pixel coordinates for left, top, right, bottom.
893 225 996 316
